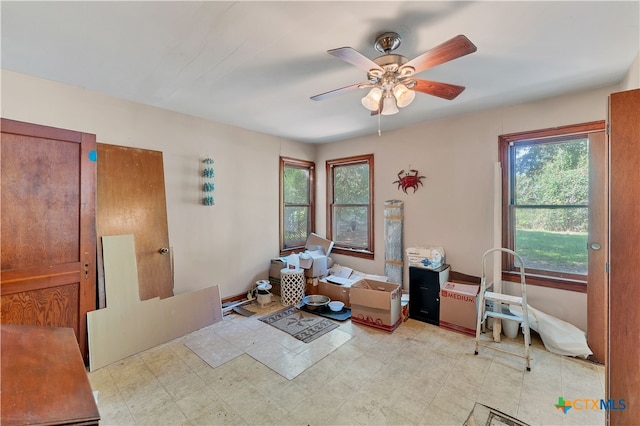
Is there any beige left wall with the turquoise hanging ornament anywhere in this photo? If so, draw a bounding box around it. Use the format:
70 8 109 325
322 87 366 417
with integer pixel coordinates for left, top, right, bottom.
1 70 315 298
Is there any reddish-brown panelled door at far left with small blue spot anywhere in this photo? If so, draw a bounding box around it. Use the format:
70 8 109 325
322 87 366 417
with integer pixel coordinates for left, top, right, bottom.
0 119 96 360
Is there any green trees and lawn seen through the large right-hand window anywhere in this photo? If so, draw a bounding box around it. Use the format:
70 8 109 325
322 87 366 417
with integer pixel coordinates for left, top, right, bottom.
510 137 589 276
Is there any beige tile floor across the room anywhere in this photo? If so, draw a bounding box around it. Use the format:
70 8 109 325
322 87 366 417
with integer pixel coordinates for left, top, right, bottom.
88 303 605 425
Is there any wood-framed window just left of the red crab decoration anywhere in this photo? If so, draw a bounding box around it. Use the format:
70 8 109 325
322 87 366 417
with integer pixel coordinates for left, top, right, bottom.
327 154 373 259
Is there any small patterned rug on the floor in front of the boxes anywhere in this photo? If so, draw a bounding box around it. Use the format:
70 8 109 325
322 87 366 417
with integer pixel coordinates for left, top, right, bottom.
260 306 338 343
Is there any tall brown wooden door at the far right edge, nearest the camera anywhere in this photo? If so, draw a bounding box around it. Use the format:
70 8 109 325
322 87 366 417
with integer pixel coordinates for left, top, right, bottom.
606 89 640 425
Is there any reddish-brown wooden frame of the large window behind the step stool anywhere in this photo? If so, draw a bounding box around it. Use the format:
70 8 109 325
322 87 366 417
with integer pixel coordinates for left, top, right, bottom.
498 121 605 293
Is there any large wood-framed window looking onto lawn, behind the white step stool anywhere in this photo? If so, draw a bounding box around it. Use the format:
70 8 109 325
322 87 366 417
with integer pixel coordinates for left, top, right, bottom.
499 122 604 291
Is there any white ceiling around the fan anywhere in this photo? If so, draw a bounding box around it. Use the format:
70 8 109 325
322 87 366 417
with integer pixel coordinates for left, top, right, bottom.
1 0 640 143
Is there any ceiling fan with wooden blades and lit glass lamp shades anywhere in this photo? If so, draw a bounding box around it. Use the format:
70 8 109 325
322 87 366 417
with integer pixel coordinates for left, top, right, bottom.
311 32 477 115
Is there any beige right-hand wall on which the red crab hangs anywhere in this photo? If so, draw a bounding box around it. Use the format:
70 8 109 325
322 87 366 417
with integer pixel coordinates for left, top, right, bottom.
316 86 619 330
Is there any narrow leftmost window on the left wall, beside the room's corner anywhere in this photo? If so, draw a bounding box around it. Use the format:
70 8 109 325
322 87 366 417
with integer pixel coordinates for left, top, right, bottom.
280 157 315 255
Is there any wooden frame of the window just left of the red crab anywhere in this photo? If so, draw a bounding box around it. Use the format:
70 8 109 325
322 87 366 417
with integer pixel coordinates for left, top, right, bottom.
326 154 375 259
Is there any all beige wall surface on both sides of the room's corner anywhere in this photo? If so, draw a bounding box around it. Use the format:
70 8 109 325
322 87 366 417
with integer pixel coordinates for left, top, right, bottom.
1 65 637 329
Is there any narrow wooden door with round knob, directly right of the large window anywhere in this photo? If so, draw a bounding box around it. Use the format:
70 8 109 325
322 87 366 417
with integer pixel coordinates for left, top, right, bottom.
587 132 609 364
